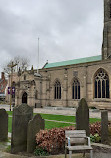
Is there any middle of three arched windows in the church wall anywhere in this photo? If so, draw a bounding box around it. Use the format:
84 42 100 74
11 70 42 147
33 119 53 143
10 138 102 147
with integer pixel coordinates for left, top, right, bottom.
72 78 80 99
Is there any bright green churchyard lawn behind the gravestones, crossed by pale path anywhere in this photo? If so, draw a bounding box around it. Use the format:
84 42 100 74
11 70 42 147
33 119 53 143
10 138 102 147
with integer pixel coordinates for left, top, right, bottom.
7 111 101 132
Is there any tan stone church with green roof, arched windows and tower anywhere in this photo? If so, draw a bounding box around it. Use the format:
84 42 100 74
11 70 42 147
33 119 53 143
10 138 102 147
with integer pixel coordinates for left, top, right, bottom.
7 0 111 109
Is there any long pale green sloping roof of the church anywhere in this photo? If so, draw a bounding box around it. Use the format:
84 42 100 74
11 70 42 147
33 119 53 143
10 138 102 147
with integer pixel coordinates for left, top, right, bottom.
44 55 102 68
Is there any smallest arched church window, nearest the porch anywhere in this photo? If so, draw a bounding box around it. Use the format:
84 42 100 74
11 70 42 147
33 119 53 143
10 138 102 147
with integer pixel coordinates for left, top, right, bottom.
54 81 61 99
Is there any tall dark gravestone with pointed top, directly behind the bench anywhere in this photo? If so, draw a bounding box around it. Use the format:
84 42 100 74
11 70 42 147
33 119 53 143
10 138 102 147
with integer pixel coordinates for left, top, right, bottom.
76 98 90 136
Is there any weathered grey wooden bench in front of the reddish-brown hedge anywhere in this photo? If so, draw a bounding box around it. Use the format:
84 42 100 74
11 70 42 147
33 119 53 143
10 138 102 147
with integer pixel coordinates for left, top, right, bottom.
65 130 93 158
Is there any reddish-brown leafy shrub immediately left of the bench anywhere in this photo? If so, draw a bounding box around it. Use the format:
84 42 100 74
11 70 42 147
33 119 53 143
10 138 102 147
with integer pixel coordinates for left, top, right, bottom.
36 126 75 154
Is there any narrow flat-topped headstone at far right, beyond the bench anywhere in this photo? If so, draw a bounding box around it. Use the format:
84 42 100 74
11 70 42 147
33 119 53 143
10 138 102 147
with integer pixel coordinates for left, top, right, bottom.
101 110 108 144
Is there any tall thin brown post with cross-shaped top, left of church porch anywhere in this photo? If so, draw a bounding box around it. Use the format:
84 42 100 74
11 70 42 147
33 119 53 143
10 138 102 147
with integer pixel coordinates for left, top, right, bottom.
8 62 17 111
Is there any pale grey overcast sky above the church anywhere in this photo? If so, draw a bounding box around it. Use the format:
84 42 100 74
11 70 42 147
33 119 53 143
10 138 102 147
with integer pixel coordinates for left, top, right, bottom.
0 0 103 75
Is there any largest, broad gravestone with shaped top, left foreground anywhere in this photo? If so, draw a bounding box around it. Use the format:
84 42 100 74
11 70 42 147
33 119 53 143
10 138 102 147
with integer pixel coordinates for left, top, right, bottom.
11 104 33 153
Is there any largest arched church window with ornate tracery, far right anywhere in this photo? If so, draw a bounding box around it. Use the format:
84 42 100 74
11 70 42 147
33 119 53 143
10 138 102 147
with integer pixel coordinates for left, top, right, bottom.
94 69 109 98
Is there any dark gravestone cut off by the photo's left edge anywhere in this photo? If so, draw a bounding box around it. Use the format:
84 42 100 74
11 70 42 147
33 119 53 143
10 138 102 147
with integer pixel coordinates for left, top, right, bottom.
0 109 8 141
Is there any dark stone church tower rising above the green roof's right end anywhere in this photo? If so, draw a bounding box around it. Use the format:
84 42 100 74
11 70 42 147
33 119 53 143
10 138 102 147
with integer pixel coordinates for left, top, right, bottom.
102 0 111 60
